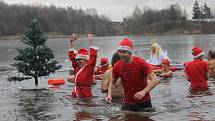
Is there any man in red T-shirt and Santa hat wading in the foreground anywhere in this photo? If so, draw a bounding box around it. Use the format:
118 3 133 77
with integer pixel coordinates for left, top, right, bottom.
106 38 159 111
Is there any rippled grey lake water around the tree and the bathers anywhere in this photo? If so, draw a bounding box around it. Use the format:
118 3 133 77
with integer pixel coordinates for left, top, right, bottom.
0 35 215 121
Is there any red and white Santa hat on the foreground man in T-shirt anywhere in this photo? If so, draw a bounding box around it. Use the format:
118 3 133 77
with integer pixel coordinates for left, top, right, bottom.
117 38 133 53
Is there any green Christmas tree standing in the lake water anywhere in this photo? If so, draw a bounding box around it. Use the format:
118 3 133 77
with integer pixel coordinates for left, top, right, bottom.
8 17 61 86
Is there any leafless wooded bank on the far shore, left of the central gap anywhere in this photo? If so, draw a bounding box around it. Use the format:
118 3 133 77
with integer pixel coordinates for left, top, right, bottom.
0 1 114 36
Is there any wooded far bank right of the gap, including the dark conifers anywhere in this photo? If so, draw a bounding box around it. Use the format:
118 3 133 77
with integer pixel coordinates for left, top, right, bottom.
124 2 215 34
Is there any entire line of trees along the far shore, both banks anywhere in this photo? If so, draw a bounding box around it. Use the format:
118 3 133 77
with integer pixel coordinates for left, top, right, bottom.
0 1 215 36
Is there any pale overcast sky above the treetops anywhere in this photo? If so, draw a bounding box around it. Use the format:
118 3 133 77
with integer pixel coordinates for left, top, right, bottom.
3 0 215 21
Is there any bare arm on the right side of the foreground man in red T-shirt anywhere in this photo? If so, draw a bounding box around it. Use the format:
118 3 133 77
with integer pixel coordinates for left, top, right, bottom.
134 72 159 100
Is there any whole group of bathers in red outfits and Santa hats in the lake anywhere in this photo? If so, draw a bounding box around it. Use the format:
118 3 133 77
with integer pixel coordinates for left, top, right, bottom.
68 34 215 111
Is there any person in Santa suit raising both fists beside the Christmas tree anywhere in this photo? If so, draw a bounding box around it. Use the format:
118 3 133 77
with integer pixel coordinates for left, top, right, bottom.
68 34 98 98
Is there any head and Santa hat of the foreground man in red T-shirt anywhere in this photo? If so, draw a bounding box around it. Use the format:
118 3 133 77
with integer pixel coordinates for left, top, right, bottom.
117 38 133 62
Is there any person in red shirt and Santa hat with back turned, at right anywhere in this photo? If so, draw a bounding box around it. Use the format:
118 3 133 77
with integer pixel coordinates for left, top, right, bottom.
185 47 208 89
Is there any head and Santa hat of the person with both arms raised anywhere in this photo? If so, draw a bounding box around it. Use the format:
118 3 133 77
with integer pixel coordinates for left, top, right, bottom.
75 48 89 67
